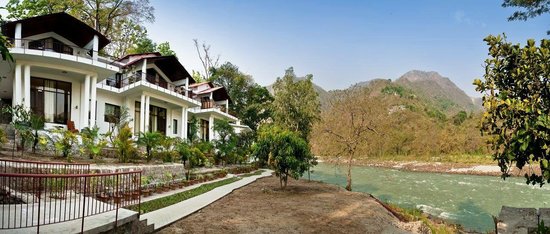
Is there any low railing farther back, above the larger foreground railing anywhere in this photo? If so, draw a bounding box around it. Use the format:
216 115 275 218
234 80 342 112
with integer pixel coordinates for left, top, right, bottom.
0 159 90 174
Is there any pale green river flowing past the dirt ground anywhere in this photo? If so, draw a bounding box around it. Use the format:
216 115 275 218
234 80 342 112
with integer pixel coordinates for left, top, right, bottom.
305 163 550 232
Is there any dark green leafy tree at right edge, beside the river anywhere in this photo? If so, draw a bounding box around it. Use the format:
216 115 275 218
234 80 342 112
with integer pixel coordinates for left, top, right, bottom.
474 35 550 186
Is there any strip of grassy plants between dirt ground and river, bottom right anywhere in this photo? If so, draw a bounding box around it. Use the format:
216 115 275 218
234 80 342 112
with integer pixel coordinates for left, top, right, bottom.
384 202 462 234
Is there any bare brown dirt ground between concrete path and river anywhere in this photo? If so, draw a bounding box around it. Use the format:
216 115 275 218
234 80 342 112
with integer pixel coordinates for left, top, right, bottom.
160 176 421 233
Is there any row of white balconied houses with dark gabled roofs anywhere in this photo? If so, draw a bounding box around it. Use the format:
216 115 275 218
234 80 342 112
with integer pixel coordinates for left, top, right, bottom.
0 13 247 140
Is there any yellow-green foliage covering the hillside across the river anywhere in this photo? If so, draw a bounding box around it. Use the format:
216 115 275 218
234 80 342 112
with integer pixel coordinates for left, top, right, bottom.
310 82 490 160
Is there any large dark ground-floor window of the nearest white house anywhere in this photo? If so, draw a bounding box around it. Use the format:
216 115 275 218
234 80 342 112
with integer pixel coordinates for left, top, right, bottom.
31 77 72 124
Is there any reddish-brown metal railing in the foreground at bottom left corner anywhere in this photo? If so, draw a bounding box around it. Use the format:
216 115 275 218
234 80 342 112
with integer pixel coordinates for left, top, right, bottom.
0 171 141 233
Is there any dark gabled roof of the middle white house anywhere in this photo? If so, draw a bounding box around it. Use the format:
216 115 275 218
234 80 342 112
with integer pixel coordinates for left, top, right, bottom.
118 52 196 84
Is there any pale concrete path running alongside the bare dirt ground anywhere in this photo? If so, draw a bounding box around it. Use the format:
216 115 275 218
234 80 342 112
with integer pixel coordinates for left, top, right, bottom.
140 169 273 230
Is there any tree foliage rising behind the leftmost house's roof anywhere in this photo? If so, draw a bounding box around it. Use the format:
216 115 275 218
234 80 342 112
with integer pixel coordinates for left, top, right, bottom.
6 0 155 57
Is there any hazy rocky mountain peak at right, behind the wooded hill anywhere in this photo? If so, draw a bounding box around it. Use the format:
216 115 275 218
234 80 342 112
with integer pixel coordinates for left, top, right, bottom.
395 70 481 113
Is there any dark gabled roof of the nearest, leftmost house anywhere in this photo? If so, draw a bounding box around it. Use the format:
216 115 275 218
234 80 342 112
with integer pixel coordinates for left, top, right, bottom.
2 12 110 50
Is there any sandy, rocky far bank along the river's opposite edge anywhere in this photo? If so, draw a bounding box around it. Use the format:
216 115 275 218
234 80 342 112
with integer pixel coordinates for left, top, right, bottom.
318 157 540 176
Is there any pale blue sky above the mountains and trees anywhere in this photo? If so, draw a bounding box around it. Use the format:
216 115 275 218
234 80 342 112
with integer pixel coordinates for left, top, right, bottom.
0 0 550 96
